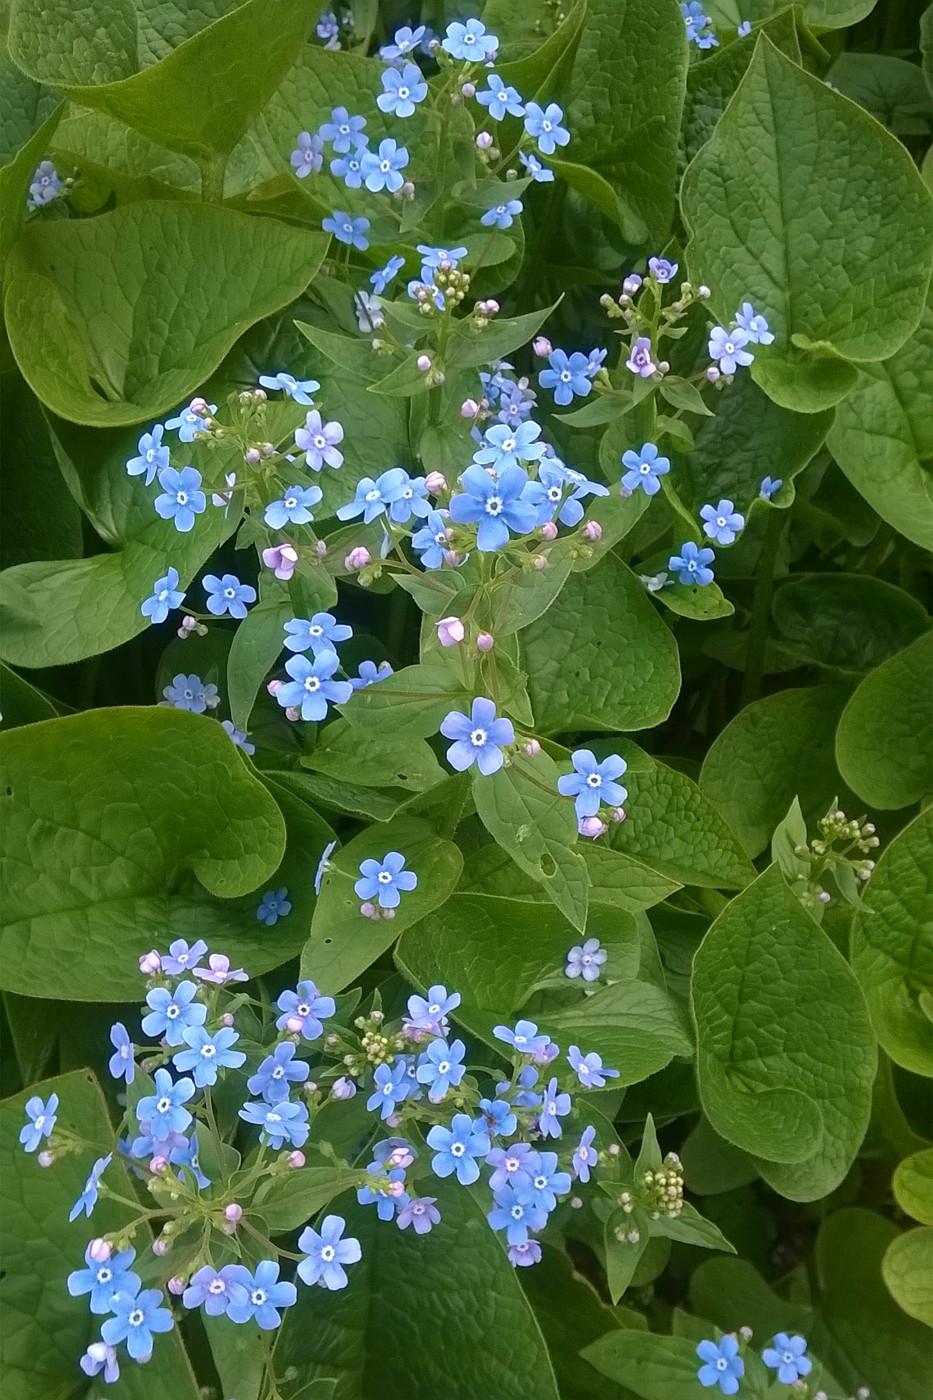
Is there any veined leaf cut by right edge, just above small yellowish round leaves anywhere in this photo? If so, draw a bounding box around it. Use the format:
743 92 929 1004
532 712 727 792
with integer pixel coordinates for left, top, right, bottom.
850 808 933 1078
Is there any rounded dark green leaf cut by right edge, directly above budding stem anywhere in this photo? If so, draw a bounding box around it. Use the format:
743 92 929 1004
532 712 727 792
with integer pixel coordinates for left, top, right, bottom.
836 633 933 808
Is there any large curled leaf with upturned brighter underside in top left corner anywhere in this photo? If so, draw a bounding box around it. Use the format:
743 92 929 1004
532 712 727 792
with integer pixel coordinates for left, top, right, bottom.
10 0 319 160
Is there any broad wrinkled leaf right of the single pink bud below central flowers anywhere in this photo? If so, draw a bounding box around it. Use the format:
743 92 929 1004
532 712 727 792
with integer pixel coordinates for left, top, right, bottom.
521 554 681 734
